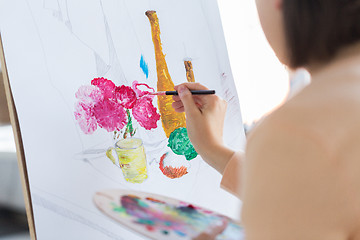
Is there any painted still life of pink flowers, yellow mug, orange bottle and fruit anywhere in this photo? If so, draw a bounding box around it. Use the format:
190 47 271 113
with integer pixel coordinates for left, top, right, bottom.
74 11 202 183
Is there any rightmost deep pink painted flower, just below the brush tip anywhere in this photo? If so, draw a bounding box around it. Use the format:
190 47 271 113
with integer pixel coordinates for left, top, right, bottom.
132 96 160 130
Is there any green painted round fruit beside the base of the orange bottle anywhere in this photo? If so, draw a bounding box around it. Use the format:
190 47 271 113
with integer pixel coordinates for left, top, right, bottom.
168 128 198 161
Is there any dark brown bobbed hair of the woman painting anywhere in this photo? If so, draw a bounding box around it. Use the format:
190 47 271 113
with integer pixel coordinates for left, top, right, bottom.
283 0 360 68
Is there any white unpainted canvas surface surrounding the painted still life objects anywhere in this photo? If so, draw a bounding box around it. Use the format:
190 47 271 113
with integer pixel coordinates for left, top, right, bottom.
0 0 245 240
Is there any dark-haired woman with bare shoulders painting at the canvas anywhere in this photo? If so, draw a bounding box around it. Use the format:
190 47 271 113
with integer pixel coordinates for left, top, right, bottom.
173 0 360 240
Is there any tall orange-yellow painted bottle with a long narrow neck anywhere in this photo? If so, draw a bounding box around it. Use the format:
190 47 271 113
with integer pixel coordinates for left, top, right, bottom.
145 11 186 138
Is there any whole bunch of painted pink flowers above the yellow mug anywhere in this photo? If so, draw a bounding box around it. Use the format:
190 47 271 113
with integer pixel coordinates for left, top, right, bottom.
74 78 160 134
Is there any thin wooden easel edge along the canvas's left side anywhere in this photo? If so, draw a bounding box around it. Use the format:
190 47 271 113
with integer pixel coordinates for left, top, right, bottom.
0 35 36 240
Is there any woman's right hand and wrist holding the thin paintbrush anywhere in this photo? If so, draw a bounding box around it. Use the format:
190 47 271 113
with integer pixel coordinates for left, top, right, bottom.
172 83 234 173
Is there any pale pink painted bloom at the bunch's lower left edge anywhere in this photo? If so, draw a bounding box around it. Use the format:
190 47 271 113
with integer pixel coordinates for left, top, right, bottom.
74 102 97 134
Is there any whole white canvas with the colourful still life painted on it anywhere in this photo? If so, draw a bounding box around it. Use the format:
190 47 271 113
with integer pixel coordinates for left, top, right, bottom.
0 0 245 240
